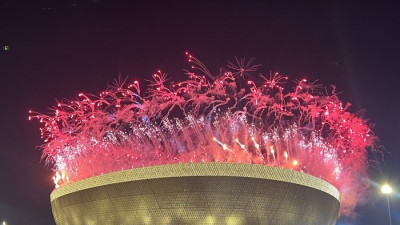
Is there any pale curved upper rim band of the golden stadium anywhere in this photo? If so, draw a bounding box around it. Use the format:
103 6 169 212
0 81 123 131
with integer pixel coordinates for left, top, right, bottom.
50 162 340 202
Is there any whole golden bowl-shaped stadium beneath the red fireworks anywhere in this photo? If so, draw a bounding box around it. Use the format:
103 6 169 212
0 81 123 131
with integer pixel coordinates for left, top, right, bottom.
51 163 340 225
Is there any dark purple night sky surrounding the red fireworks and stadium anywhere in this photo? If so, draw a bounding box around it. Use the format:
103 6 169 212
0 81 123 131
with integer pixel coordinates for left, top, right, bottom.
0 0 400 225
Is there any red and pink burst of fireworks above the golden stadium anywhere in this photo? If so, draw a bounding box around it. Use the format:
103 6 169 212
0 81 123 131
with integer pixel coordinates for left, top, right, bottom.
29 53 375 215
